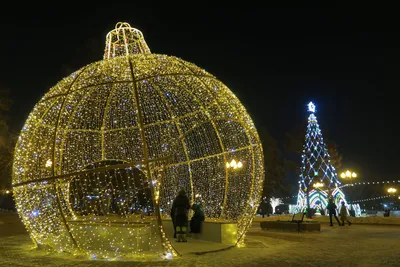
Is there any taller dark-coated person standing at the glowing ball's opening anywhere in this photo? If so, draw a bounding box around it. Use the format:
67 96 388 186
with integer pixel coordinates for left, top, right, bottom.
171 189 190 242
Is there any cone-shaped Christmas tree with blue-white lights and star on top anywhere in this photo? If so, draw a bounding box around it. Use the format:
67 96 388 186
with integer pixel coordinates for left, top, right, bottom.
297 102 346 217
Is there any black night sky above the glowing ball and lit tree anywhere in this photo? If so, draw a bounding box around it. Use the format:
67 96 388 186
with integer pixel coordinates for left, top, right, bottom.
0 7 400 184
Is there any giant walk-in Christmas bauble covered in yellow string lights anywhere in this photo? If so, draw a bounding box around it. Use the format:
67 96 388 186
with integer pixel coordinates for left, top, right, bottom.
13 23 264 257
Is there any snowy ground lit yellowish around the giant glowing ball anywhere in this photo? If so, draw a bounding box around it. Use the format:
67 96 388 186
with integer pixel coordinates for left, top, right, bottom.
0 214 400 267
